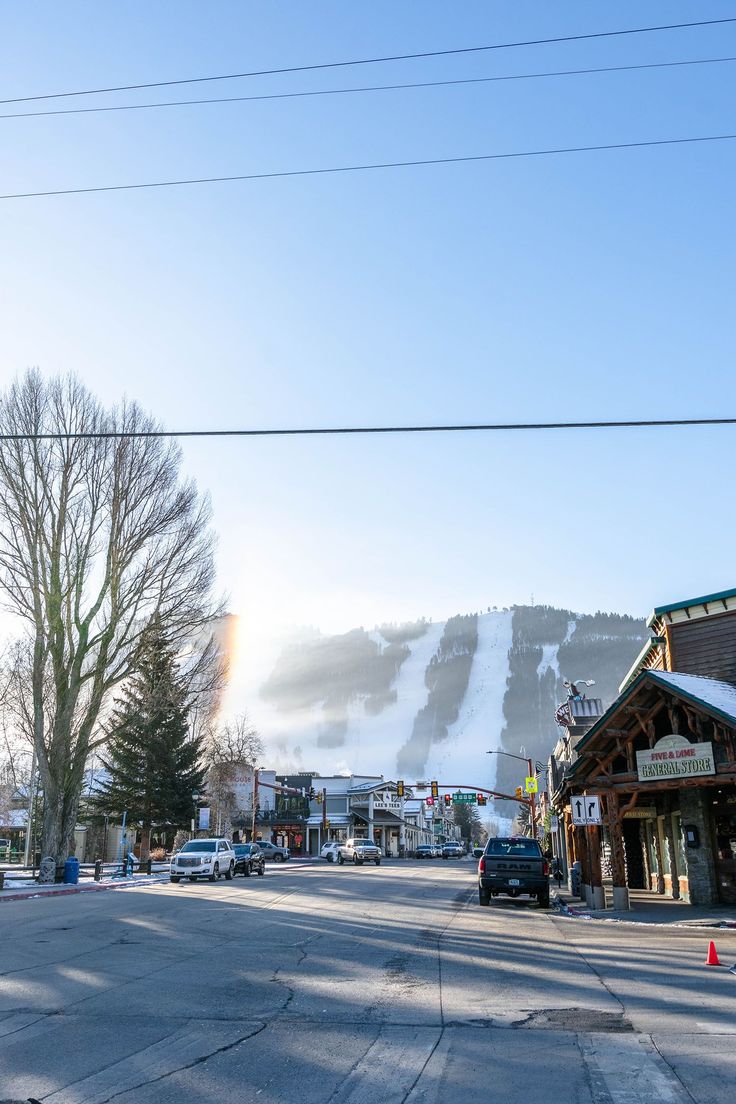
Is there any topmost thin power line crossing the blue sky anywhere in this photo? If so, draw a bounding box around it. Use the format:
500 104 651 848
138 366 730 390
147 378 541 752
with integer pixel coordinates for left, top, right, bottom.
0 17 736 104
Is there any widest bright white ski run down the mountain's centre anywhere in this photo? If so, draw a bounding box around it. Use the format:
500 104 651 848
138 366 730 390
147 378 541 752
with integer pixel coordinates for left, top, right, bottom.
436 611 513 789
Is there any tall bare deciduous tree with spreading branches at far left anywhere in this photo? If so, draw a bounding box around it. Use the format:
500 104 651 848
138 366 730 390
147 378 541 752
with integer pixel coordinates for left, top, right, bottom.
0 372 214 862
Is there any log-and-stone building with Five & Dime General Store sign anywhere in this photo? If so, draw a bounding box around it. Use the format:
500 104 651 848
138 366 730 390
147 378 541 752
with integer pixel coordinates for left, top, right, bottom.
552 590 736 907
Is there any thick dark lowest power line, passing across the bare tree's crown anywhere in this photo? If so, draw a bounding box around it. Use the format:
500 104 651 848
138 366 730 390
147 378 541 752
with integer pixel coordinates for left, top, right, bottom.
5 417 736 442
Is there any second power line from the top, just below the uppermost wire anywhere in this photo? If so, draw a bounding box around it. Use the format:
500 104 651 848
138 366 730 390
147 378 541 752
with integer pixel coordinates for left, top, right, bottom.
0 57 736 119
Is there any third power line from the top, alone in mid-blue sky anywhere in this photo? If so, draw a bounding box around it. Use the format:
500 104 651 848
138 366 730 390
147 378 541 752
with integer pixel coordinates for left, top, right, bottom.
0 134 736 200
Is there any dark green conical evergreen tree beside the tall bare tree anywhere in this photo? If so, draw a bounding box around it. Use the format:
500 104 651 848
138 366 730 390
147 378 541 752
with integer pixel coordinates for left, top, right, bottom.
97 623 204 860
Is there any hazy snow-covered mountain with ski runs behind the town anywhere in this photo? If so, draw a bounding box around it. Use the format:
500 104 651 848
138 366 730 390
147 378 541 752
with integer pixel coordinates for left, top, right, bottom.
249 606 646 792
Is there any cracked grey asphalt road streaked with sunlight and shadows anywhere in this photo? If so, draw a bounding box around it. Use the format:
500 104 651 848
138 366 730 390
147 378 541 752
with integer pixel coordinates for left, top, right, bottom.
0 861 736 1104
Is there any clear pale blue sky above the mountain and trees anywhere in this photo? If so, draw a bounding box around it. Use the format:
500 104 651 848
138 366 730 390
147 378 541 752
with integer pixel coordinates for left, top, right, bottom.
0 0 736 666
